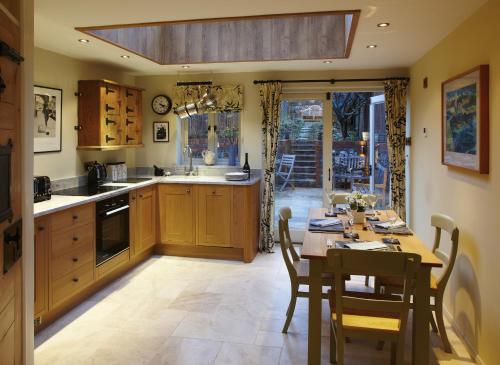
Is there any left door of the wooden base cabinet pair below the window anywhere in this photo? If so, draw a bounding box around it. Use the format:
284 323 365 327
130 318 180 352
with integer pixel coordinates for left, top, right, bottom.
158 184 196 245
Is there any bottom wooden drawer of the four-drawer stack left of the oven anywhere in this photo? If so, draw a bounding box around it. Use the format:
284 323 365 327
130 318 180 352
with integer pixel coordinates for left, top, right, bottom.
51 262 95 307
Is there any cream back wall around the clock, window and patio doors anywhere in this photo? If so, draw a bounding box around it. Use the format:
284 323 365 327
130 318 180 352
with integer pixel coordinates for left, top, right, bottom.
135 67 408 169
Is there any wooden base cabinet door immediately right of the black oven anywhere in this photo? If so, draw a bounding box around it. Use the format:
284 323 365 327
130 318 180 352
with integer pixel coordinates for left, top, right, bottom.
129 186 156 255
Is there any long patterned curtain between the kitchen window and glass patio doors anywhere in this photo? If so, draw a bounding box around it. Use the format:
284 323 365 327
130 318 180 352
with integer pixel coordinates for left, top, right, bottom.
259 82 282 252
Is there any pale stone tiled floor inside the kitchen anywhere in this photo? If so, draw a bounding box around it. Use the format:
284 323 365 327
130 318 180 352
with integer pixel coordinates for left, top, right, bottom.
35 252 471 365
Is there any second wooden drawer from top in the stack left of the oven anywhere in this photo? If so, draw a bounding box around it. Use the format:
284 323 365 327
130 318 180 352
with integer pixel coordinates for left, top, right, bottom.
51 223 95 258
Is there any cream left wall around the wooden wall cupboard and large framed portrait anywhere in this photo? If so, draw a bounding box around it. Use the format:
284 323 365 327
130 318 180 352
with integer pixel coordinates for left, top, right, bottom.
34 48 135 180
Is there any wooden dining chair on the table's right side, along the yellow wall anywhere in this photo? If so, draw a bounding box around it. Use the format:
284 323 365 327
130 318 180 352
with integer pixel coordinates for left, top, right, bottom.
375 214 459 353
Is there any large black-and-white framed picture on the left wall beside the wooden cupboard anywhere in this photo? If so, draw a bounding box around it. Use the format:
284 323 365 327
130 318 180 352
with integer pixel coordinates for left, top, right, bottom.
33 86 62 153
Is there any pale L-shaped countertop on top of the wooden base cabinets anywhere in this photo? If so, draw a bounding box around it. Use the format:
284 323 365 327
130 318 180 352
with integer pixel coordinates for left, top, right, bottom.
33 175 260 218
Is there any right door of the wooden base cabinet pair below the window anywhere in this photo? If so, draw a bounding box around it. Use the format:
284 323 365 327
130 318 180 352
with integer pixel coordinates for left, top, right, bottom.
196 185 233 247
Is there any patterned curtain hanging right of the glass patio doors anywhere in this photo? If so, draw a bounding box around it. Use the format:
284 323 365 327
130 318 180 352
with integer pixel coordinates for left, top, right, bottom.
384 80 408 220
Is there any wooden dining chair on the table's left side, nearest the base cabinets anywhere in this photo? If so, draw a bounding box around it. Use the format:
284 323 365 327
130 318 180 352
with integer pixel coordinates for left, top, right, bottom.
279 207 333 333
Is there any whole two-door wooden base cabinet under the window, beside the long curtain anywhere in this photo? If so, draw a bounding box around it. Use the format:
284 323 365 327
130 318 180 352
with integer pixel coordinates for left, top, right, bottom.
156 181 260 262
